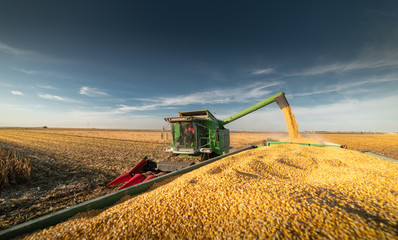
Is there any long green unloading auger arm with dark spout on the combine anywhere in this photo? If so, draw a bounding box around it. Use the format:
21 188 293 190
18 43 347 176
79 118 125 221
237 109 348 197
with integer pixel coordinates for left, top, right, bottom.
219 92 289 126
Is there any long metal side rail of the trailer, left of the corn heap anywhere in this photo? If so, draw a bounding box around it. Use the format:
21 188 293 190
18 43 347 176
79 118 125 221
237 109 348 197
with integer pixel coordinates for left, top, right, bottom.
0 146 255 239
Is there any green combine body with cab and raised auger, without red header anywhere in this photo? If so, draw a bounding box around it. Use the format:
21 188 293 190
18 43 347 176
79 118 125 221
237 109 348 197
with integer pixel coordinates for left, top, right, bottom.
164 92 289 160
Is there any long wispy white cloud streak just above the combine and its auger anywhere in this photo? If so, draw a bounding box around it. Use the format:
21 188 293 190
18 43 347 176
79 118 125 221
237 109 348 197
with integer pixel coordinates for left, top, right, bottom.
118 82 283 112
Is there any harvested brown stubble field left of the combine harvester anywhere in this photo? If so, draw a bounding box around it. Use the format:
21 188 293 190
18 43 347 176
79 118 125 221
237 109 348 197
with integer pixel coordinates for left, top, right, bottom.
0 129 178 230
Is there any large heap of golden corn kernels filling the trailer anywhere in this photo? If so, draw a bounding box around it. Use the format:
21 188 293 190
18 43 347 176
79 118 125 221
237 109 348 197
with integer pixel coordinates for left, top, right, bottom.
26 145 398 239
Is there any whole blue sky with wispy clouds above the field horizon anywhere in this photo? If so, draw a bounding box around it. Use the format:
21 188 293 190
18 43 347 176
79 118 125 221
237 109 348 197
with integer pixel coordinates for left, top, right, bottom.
0 0 398 132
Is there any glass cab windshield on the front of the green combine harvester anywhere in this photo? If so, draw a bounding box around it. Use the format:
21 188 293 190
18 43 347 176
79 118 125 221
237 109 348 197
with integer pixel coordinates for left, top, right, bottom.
171 122 197 148
